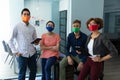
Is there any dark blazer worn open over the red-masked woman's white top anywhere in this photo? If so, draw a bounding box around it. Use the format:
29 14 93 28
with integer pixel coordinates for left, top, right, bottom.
86 33 118 57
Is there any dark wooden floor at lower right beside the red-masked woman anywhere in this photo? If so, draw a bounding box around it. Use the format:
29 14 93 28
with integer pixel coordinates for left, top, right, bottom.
104 55 120 80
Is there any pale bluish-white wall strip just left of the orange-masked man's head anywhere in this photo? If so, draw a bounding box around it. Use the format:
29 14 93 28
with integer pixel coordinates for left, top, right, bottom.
9 0 24 29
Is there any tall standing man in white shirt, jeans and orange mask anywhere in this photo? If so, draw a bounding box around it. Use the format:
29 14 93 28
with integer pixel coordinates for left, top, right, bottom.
9 8 37 80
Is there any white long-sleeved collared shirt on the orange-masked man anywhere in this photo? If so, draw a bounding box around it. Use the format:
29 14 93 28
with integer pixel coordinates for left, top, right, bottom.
9 22 37 57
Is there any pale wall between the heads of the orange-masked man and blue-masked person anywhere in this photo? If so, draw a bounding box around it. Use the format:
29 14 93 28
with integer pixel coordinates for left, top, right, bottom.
25 0 52 37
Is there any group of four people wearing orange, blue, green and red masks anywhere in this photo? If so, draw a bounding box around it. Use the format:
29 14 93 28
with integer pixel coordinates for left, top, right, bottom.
10 8 117 80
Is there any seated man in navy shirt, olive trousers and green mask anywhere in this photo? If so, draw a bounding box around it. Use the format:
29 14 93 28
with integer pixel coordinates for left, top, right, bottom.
60 20 87 80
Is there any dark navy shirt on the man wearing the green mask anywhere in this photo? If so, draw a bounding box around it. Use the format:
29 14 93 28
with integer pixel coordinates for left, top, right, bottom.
66 31 87 62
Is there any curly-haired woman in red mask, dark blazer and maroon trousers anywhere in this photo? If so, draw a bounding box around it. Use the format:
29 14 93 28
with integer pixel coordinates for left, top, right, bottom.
78 18 117 80
